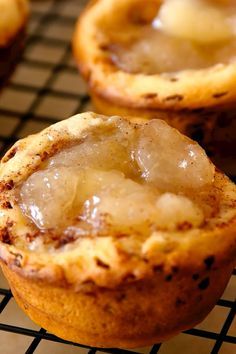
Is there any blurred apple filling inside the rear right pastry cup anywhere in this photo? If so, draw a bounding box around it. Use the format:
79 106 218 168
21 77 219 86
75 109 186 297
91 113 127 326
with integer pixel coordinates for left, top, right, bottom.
110 0 236 74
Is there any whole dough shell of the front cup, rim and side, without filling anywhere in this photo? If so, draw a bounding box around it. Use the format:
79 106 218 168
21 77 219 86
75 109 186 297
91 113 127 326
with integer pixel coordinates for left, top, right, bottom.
0 113 236 348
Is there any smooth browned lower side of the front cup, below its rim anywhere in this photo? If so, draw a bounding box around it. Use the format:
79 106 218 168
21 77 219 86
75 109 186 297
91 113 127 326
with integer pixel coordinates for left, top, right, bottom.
2 263 233 348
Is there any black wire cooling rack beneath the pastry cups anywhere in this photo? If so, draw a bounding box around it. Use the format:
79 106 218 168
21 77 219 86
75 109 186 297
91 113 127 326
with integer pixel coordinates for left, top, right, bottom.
0 0 236 354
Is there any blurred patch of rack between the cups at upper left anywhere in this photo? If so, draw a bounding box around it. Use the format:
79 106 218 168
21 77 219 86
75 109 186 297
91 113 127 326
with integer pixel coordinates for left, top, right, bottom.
0 0 91 160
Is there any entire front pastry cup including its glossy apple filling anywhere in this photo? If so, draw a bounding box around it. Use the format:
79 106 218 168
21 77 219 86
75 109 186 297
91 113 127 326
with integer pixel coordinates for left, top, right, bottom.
0 113 236 348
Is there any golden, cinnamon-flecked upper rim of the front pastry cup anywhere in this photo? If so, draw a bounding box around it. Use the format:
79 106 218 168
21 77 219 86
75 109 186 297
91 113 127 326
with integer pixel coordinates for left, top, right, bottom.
0 113 236 289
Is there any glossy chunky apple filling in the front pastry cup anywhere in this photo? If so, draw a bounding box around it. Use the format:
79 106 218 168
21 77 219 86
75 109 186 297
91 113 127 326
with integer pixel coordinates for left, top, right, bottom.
20 117 214 245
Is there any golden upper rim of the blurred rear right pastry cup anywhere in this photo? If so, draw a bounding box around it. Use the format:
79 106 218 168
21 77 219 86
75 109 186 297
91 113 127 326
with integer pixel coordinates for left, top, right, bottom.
73 0 236 110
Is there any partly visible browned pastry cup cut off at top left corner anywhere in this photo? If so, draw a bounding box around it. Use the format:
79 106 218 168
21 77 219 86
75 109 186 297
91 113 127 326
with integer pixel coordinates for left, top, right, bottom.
0 0 29 88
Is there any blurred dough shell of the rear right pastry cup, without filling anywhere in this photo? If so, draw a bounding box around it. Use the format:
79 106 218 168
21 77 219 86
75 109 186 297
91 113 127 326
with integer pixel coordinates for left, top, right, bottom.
73 0 236 174
